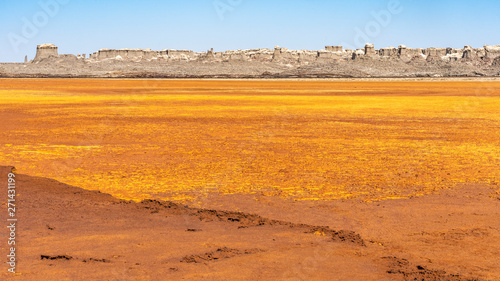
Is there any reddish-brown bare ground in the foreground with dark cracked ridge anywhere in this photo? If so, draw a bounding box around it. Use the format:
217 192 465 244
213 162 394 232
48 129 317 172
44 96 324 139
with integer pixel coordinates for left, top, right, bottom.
0 167 500 280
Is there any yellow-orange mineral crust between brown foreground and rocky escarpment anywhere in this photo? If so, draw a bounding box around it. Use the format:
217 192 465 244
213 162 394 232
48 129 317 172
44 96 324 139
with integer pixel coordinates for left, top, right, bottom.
0 79 500 202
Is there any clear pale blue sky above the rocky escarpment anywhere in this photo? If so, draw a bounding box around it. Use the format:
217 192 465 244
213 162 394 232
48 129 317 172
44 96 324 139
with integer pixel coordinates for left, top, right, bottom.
0 0 500 62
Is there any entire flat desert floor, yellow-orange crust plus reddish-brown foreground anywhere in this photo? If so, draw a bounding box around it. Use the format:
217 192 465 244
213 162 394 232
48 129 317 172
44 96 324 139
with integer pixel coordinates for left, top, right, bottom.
0 79 500 280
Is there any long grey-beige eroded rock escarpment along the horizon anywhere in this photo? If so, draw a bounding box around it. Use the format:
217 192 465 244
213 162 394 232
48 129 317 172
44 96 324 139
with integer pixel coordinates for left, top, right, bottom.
0 44 500 78
